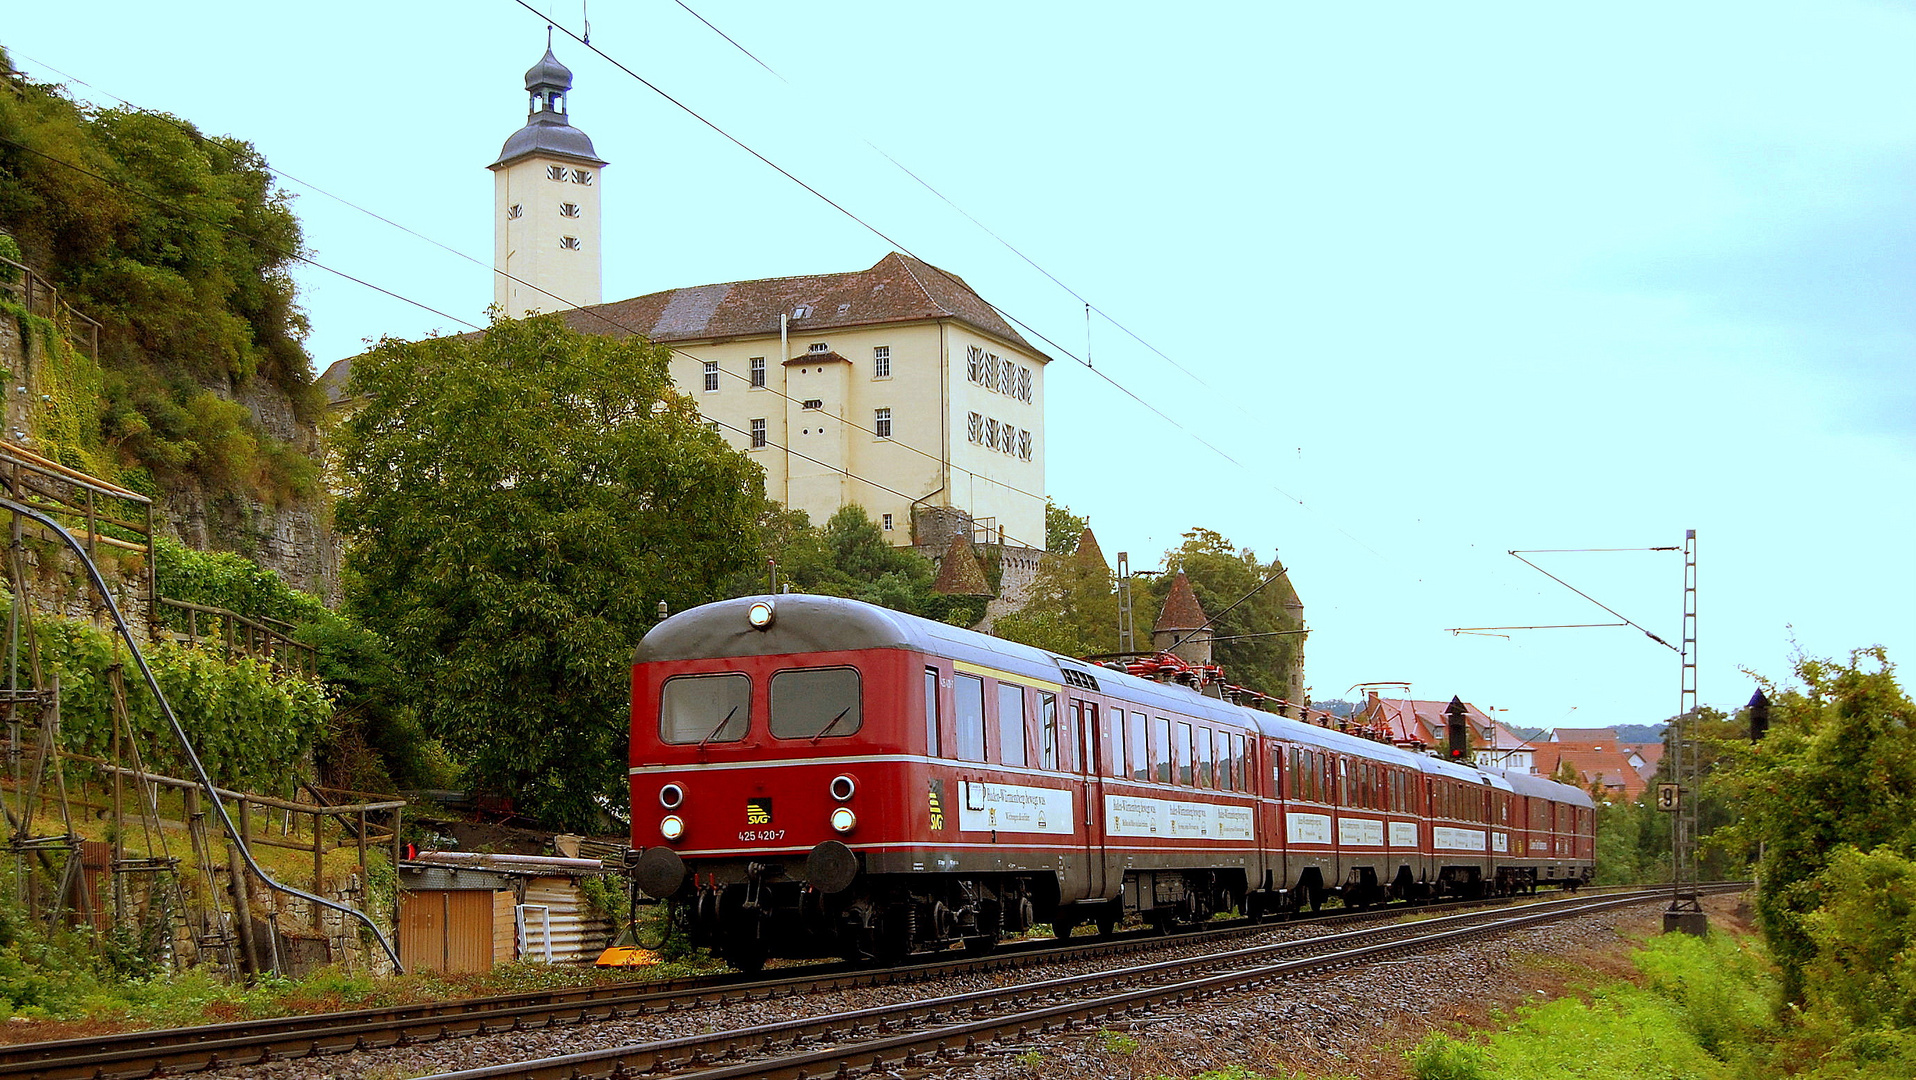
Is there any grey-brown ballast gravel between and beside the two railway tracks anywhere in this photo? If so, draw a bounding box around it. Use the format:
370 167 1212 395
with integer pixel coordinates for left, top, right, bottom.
203 902 1721 1080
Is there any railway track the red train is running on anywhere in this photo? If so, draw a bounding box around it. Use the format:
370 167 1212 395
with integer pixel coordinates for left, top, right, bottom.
0 892 1739 1080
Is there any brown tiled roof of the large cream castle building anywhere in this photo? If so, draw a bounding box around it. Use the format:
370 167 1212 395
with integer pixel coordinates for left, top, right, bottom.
561 251 1050 354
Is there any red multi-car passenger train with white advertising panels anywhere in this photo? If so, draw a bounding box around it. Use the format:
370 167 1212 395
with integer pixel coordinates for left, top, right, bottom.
632 596 1594 969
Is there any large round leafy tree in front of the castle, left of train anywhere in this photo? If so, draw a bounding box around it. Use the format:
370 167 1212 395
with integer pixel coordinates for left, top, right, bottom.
337 316 764 827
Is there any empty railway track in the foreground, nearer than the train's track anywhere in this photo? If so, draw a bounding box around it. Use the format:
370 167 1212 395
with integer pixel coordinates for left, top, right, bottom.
433 889 1747 1080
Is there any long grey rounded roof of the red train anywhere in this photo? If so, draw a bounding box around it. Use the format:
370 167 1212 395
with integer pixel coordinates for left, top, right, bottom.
632 594 1594 806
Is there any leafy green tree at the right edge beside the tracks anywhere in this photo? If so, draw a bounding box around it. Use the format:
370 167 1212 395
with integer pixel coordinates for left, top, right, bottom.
1717 647 1916 1000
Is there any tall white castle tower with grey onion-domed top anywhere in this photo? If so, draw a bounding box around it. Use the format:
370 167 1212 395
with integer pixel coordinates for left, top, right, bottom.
489 42 605 318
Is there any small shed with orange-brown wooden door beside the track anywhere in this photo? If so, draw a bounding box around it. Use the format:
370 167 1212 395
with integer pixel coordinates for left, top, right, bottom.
399 852 619 973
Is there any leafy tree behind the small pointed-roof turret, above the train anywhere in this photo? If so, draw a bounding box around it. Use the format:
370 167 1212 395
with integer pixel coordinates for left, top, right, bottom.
1138 529 1305 701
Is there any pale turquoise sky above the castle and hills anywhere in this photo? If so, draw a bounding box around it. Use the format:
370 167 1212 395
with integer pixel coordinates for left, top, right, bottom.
0 0 1916 728
